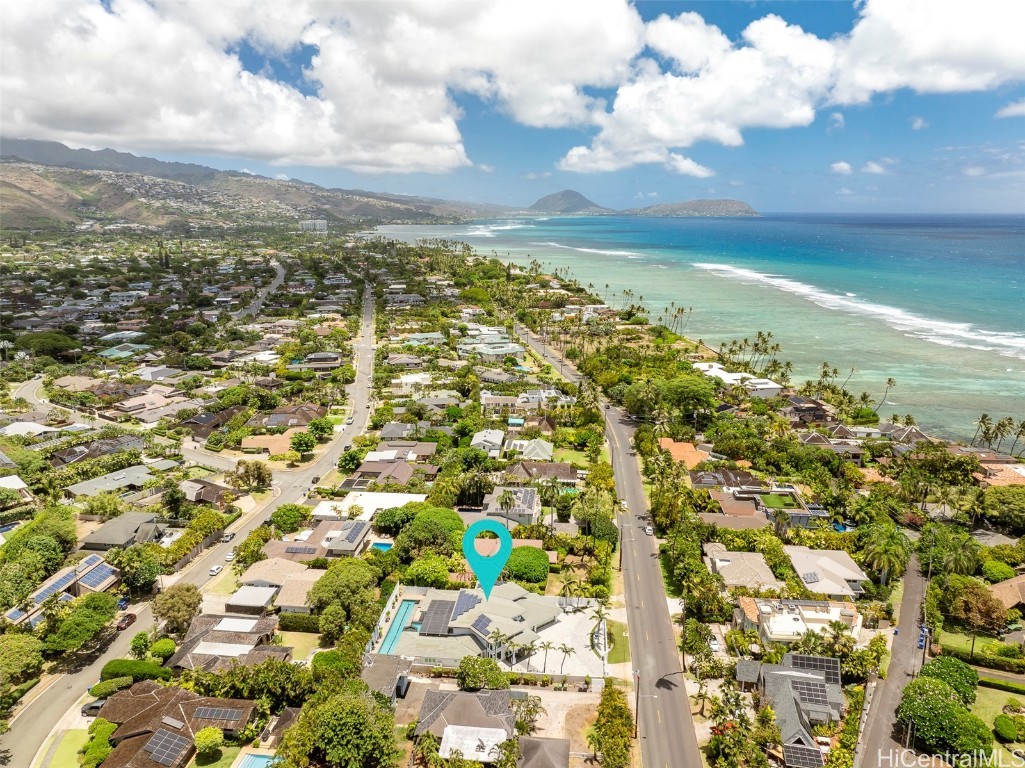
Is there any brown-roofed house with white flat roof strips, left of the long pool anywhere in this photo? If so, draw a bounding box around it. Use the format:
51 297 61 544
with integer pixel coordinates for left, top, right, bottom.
166 613 292 672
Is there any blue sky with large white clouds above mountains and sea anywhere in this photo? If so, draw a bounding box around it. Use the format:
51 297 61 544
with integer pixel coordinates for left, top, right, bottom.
0 0 1025 213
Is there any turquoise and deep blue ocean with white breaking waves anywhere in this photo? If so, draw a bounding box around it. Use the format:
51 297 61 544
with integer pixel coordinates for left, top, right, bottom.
377 214 1025 448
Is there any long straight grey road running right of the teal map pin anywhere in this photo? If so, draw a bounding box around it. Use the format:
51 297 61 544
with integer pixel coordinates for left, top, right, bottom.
517 326 702 768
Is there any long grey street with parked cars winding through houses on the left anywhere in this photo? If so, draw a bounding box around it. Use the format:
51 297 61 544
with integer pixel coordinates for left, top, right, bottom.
0 283 374 768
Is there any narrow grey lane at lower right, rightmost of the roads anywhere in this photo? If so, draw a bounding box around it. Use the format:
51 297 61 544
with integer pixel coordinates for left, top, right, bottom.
855 555 926 768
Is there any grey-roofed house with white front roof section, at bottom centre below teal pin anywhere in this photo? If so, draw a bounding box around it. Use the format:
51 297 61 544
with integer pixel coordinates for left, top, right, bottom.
415 690 516 763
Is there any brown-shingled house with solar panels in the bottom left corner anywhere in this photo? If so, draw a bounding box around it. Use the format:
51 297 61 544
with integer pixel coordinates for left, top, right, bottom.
99 680 256 768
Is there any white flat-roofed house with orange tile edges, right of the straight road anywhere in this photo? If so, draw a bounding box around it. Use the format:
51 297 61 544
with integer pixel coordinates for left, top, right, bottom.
733 596 863 645
